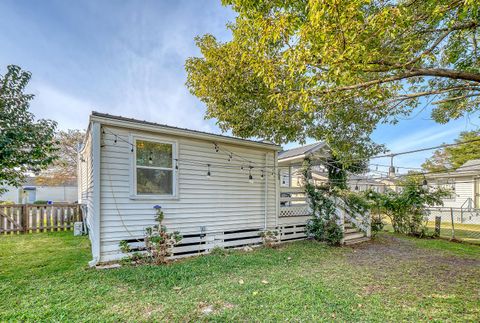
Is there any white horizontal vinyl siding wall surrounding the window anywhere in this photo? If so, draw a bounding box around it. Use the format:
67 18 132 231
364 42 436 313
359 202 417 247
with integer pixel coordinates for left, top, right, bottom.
100 126 277 261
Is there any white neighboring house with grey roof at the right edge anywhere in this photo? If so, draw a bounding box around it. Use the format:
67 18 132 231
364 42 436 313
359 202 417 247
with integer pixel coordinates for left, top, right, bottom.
427 159 480 209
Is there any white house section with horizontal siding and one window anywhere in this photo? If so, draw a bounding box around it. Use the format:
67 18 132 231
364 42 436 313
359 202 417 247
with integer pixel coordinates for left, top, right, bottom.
78 112 288 264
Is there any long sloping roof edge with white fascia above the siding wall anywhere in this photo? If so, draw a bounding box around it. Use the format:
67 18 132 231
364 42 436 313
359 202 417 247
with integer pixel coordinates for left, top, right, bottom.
90 111 281 150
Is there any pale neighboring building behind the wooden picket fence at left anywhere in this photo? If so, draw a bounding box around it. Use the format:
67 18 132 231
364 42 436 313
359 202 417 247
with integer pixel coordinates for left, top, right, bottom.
0 177 78 204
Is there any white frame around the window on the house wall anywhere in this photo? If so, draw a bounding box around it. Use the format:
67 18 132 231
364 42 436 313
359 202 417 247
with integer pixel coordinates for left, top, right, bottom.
130 134 179 200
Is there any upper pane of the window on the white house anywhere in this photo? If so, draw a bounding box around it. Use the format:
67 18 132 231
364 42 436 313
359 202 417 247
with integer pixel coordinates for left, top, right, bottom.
137 140 172 168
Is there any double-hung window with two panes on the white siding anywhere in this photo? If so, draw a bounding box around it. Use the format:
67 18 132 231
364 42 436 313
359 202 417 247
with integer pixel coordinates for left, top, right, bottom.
135 139 175 196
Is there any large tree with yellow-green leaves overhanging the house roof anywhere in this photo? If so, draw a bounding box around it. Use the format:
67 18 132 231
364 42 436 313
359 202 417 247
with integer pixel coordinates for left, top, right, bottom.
186 0 480 158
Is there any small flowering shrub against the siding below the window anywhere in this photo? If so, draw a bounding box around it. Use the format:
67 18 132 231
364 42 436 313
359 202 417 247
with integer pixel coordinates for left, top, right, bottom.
119 205 182 265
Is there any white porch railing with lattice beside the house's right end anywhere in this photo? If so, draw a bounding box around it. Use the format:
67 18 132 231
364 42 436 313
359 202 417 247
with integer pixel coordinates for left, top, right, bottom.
279 187 310 217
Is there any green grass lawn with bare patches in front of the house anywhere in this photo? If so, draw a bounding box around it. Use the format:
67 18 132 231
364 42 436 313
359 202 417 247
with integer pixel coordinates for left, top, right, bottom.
0 232 480 321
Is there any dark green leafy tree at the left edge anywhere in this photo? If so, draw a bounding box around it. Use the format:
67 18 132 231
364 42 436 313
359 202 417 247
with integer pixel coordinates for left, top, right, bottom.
0 65 56 192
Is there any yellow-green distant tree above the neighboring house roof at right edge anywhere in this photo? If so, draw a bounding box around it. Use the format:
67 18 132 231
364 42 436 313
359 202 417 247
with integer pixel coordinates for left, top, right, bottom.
422 130 480 172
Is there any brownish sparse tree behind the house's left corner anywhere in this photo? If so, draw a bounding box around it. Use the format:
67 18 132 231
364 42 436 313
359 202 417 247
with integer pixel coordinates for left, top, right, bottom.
36 129 85 185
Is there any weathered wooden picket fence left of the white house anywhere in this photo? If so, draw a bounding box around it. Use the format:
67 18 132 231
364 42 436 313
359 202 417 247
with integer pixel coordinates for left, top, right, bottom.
0 204 82 234
